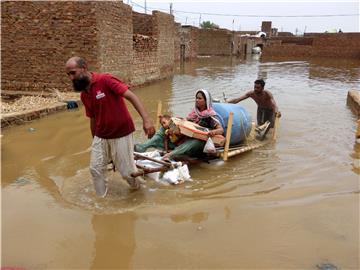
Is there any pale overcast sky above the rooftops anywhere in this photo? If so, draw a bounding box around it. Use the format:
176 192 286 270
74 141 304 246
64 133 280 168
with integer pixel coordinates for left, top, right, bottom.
129 0 360 34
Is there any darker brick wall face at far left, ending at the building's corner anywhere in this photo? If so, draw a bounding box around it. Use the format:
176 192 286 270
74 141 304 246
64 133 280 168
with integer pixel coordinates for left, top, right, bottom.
1 1 99 91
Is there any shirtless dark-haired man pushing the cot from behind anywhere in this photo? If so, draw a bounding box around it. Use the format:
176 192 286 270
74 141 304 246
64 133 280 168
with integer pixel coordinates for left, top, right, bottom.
227 79 281 131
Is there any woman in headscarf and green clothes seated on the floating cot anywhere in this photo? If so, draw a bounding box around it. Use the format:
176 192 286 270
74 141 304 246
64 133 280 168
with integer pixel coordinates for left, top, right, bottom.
135 89 224 159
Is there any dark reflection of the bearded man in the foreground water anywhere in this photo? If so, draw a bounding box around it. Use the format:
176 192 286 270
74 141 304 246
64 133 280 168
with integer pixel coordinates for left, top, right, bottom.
91 213 137 269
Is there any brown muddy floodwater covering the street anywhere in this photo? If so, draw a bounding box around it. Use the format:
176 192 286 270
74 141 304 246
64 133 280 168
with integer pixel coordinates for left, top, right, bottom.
1 58 360 269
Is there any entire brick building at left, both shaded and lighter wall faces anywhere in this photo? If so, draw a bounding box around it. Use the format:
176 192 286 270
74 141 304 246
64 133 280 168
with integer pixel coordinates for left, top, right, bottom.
1 1 180 91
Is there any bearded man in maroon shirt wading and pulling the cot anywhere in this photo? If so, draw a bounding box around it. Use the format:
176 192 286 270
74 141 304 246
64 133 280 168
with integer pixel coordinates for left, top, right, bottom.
65 56 155 197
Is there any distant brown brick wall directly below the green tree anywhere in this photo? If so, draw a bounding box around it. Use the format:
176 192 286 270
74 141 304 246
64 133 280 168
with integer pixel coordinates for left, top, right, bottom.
198 29 232 55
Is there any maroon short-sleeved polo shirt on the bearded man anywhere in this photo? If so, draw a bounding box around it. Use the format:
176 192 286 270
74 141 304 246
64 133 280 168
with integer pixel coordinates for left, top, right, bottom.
80 72 135 139
